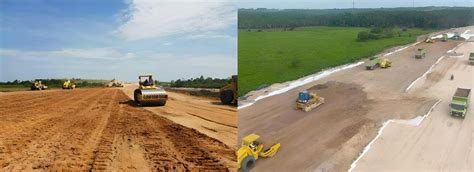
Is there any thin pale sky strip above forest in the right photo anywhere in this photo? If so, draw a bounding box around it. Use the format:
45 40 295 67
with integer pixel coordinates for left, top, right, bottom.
238 0 474 9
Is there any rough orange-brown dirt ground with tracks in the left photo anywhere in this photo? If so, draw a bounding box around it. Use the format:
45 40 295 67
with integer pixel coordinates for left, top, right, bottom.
0 88 235 171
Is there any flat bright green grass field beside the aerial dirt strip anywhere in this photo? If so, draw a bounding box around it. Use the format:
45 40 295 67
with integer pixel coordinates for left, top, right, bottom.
238 27 433 96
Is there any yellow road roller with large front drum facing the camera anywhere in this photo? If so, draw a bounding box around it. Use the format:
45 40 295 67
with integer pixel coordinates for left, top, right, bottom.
133 74 168 106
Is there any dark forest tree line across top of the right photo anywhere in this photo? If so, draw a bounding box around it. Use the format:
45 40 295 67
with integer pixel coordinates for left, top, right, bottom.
238 7 474 30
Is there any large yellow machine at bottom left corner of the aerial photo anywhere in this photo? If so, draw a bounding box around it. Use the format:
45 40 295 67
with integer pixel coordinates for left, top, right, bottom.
235 134 281 172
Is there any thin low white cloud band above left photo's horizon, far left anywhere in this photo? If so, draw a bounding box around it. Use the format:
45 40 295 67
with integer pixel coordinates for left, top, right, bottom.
0 48 136 60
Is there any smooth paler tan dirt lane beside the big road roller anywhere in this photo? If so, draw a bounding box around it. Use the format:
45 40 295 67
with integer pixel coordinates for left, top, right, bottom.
123 83 237 147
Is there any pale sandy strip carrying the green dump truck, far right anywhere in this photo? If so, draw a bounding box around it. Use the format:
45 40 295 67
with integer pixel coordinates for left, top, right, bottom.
354 42 474 172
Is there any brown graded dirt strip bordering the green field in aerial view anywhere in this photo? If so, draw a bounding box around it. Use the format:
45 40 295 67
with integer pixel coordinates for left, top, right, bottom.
238 27 463 171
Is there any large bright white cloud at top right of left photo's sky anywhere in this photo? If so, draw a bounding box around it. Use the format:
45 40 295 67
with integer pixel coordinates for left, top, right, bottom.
116 0 237 40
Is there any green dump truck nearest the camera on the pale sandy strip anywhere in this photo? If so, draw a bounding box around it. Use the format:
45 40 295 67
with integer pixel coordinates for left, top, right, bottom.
450 88 471 118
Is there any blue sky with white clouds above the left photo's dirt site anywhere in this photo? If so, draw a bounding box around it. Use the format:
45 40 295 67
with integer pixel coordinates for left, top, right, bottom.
0 0 237 81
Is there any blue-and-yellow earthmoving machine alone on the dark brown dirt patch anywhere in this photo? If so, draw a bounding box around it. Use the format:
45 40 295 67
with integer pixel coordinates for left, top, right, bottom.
296 91 324 112
